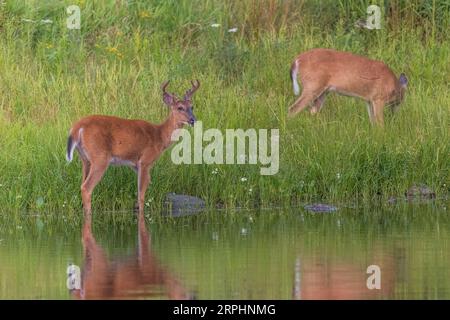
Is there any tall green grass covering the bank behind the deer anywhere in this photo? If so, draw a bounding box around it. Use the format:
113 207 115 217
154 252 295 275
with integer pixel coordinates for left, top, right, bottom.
0 0 450 211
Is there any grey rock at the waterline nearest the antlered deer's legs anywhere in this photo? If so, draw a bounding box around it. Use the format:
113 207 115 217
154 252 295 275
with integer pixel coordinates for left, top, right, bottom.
164 193 205 217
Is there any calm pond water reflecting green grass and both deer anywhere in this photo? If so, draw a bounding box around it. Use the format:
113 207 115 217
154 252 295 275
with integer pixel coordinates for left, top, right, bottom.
0 202 450 299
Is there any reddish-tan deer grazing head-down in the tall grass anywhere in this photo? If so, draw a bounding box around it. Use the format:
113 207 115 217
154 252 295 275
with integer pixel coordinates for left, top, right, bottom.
289 49 408 125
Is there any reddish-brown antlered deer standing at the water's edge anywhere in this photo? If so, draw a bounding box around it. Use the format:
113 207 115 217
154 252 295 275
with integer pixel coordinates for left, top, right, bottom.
66 80 200 214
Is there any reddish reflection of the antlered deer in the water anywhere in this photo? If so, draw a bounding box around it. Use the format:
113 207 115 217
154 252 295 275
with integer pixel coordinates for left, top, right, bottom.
71 214 193 299
